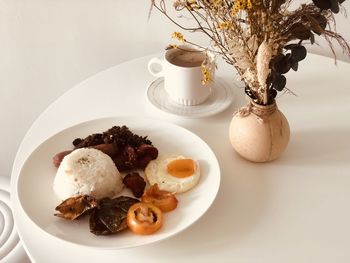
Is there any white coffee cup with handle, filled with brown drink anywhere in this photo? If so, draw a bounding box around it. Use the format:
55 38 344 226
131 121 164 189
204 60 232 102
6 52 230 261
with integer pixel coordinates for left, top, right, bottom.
148 45 214 106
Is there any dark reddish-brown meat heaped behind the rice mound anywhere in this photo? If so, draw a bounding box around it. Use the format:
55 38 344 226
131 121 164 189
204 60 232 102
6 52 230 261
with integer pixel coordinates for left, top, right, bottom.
53 126 158 172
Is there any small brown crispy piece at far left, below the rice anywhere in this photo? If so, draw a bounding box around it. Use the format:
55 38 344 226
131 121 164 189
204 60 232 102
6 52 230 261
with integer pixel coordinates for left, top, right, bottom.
55 195 98 220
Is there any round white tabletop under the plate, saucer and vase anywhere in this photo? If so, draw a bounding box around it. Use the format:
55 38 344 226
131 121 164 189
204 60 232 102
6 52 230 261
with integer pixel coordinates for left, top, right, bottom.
11 54 350 263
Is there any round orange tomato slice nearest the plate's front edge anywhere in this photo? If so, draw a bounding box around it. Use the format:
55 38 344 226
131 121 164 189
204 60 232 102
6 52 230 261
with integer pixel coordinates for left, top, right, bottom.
127 202 163 235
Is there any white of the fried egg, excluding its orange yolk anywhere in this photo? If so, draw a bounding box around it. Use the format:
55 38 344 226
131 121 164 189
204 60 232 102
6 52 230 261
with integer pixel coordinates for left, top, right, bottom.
145 156 200 194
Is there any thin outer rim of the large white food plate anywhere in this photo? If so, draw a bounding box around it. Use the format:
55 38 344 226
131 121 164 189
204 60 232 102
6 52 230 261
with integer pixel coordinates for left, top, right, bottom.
15 115 221 250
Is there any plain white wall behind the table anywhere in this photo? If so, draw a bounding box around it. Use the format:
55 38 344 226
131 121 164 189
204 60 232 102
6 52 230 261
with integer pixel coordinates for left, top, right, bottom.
0 0 350 176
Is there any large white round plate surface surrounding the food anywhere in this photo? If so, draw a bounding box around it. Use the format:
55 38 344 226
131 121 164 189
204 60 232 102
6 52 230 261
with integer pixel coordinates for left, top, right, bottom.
16 117 220 249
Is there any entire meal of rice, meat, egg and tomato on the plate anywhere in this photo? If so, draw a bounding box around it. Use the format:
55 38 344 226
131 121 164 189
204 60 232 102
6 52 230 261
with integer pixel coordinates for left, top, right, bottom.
53 126 200 238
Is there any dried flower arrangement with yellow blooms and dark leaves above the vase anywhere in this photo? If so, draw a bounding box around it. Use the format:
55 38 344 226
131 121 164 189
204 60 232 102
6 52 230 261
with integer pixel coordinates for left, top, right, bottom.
151 0 350 105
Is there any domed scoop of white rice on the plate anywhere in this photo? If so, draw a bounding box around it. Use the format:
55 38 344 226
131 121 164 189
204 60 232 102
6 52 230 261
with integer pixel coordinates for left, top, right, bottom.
53 148 123 199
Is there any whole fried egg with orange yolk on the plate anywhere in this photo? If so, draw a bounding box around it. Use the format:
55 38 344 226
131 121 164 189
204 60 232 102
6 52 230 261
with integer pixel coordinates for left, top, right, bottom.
145 156 200 194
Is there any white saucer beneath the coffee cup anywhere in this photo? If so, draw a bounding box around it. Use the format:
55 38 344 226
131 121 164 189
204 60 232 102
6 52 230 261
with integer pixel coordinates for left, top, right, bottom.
147 78 234 118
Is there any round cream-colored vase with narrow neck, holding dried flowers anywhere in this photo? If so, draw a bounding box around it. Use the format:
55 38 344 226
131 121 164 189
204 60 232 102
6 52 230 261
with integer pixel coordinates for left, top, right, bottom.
229 102 290 162
